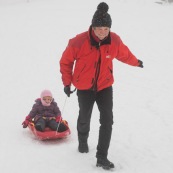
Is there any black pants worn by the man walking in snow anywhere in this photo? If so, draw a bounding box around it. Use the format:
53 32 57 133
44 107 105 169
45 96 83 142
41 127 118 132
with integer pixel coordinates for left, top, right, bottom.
77 86 113 158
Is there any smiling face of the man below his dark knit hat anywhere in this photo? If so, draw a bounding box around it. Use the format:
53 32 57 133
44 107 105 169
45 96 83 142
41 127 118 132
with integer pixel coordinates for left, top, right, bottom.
93 27 110 40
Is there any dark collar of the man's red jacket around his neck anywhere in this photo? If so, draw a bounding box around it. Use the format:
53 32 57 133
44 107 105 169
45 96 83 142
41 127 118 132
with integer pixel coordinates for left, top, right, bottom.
89 26 111 49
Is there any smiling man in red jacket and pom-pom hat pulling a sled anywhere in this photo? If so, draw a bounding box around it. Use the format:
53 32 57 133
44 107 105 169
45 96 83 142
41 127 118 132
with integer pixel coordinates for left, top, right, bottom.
60 2 143 169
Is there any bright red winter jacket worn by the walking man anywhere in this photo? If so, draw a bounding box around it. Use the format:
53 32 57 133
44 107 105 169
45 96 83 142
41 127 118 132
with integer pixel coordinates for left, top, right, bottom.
60 27 139 91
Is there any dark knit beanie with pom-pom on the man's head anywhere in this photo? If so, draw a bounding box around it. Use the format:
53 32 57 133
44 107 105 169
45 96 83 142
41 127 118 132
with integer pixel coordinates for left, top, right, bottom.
92 2 112 28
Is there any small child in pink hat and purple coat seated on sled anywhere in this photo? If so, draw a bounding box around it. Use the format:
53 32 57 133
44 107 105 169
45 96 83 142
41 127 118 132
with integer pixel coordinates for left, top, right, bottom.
22 90 67 132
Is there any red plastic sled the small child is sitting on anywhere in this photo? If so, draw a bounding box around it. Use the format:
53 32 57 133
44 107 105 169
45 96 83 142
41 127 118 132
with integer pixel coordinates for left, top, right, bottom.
28 120 71 140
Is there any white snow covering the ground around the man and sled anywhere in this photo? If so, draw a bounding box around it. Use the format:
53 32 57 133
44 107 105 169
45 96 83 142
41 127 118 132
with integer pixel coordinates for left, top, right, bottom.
0 0 173 173
